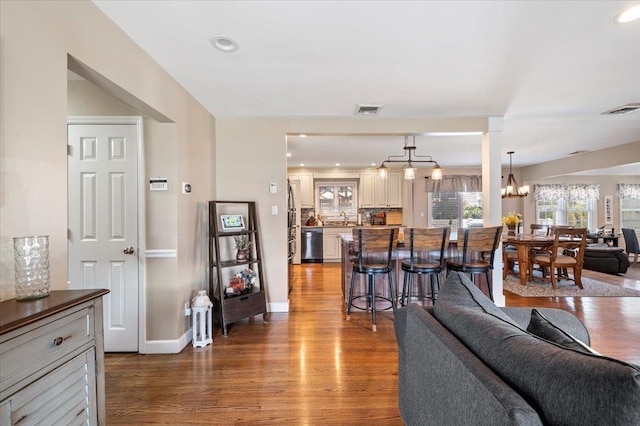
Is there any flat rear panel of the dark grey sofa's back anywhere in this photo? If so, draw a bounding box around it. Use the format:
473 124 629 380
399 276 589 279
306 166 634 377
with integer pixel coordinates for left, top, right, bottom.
394 303 542 426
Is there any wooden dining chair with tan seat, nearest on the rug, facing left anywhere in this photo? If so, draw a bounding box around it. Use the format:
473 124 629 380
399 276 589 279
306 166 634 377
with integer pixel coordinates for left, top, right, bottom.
533 227 587 289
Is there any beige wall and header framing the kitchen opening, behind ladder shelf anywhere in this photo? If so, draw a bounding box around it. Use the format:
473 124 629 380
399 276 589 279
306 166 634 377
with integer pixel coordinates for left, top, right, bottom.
216 117 487 311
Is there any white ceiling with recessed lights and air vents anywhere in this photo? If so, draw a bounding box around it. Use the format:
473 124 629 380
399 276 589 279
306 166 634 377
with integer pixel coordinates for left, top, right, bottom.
94 0 640 174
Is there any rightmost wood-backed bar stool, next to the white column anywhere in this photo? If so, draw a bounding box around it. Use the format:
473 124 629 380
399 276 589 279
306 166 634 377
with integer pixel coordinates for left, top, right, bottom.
447 226 502 300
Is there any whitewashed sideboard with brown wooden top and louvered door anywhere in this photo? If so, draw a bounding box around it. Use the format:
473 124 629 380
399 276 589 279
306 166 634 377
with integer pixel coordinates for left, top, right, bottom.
0 290 108 425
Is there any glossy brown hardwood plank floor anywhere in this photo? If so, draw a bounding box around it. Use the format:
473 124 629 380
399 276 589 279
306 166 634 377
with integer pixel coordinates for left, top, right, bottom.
105 264 640 425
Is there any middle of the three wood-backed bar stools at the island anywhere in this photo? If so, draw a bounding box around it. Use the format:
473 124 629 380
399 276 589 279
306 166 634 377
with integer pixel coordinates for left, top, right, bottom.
400 227 450 306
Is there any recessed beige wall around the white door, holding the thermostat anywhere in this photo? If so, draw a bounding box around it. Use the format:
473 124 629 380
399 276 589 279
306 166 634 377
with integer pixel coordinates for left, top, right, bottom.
67 80 189 340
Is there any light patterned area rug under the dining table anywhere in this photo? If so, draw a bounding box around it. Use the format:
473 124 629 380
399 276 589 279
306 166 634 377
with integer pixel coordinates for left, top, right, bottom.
503 275 640 297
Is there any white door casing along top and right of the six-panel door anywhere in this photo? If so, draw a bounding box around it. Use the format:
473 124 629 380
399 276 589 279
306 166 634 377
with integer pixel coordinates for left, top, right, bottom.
67 116 148 354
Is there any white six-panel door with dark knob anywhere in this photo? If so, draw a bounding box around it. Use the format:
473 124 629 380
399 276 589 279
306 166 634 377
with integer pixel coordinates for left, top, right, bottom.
67 124 138 352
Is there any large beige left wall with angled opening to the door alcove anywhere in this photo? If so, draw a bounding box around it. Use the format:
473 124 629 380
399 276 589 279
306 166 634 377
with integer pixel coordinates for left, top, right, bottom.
0 1 215 346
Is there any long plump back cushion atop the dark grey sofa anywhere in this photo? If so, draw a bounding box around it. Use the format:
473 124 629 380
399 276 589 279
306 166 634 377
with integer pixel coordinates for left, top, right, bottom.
434 277 640 425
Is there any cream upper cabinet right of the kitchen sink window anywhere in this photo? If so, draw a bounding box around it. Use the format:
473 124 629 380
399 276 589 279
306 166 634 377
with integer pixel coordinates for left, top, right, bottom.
360 170 402 208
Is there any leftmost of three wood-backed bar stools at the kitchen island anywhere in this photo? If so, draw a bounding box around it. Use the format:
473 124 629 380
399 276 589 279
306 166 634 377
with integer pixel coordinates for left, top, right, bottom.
347 228 398 332
